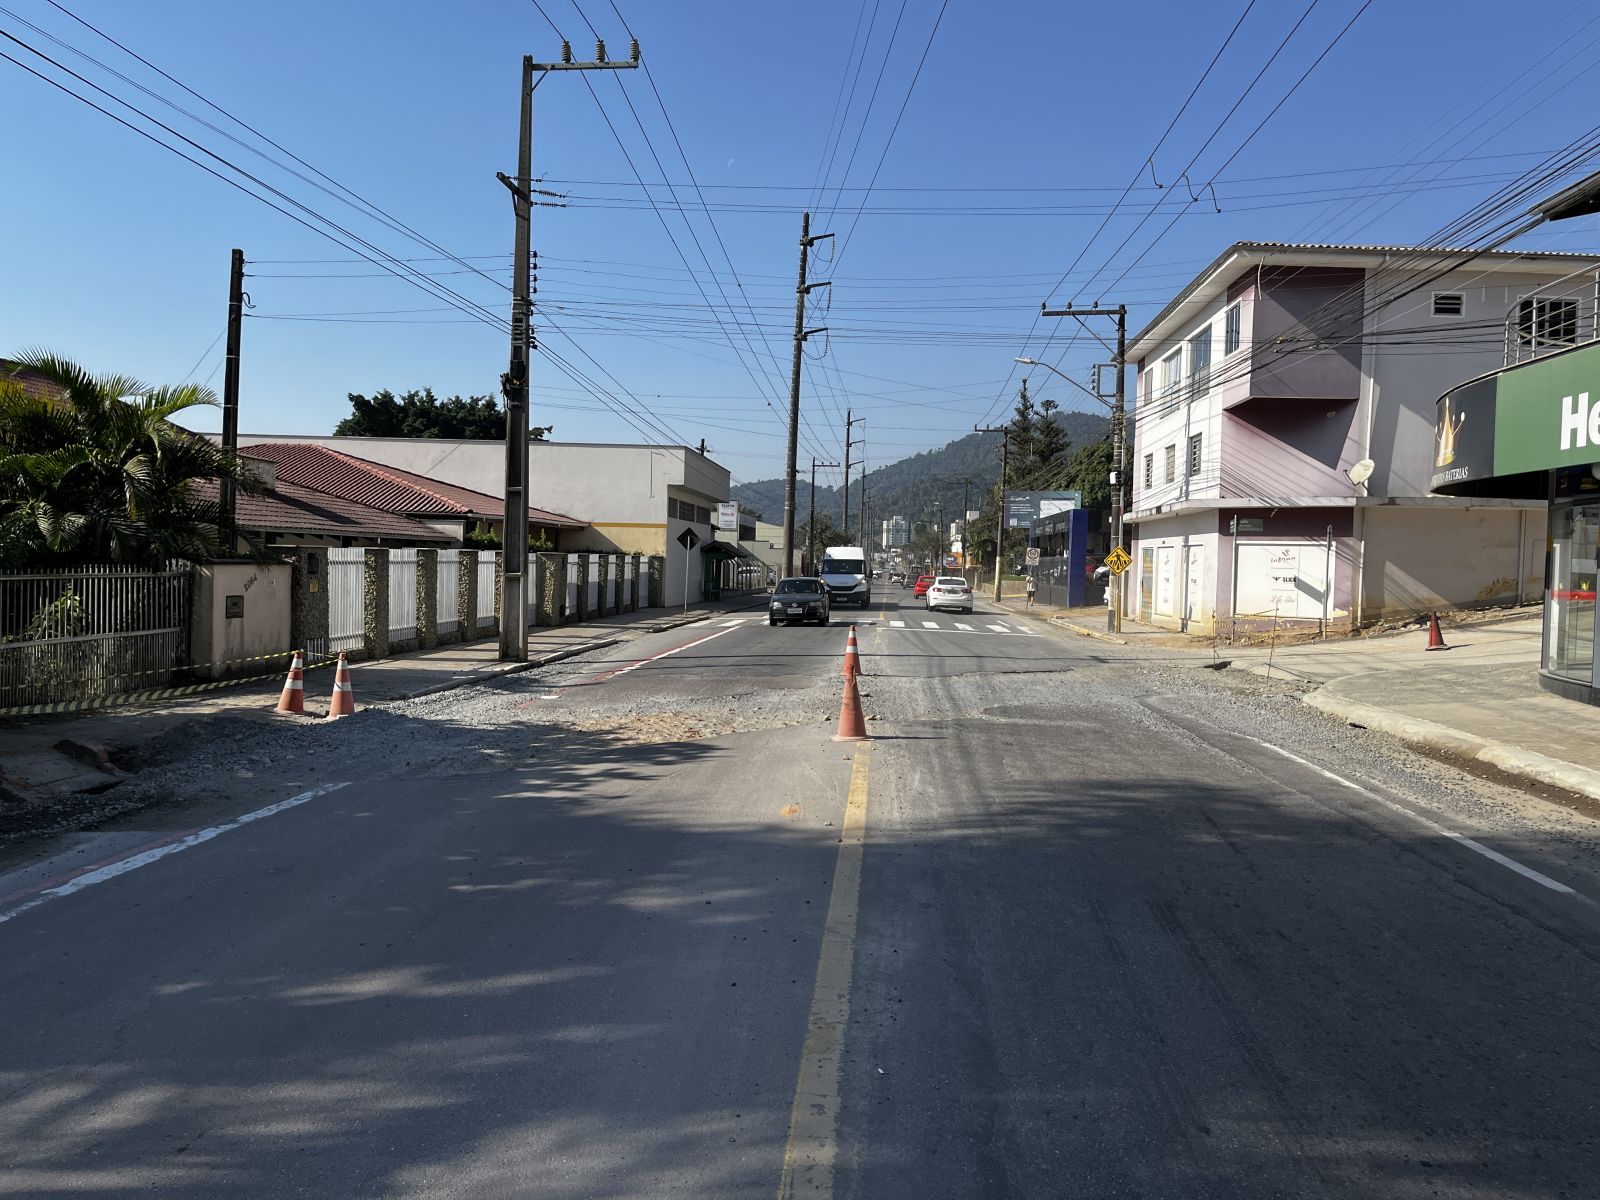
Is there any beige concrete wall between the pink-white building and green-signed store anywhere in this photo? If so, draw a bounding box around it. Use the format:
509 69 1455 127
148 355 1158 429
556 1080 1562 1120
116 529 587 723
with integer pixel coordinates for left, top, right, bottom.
1360 506 1546 621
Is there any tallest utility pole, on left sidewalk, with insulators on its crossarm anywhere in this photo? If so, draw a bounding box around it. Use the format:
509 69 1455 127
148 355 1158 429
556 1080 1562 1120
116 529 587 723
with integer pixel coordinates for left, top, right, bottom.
496 40 638 662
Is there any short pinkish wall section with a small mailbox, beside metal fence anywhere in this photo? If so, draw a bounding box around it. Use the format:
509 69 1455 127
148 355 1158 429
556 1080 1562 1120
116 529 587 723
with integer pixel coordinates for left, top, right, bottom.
189 562 294 678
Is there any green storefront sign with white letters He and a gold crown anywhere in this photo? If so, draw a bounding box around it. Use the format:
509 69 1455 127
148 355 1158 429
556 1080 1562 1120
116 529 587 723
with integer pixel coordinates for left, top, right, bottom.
1432 344 1600 499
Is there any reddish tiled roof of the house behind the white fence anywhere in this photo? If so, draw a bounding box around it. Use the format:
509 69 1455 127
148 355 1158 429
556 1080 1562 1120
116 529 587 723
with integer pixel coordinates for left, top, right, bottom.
245 442 584 530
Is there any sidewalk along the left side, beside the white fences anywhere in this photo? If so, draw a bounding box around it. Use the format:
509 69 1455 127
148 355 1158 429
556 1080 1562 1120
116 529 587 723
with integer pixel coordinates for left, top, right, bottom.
0 594 766 805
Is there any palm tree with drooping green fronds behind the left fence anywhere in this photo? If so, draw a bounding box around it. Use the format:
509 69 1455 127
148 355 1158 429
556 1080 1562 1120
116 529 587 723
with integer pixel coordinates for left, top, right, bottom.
0 350 261 568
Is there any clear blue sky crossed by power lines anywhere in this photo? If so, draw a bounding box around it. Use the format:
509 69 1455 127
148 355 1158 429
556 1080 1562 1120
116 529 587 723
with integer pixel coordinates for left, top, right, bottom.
0 0 1600 492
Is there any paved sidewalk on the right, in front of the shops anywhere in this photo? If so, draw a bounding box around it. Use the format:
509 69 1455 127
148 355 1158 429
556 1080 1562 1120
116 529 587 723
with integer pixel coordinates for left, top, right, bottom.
1003 600 1600 800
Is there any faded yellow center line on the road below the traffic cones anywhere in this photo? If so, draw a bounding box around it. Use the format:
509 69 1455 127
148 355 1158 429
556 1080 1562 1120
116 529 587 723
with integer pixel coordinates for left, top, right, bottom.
778 742 872 1200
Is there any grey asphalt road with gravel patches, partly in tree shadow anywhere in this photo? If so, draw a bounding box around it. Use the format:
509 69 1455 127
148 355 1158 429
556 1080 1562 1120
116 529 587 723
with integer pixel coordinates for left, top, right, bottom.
0 594 1600 1200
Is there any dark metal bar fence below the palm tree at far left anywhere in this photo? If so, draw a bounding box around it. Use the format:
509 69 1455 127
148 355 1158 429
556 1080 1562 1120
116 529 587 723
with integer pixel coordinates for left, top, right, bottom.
0 566 192 707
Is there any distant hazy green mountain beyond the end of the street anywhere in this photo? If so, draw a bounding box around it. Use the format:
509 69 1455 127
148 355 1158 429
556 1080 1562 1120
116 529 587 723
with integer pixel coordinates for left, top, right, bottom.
733 413 1110 526
